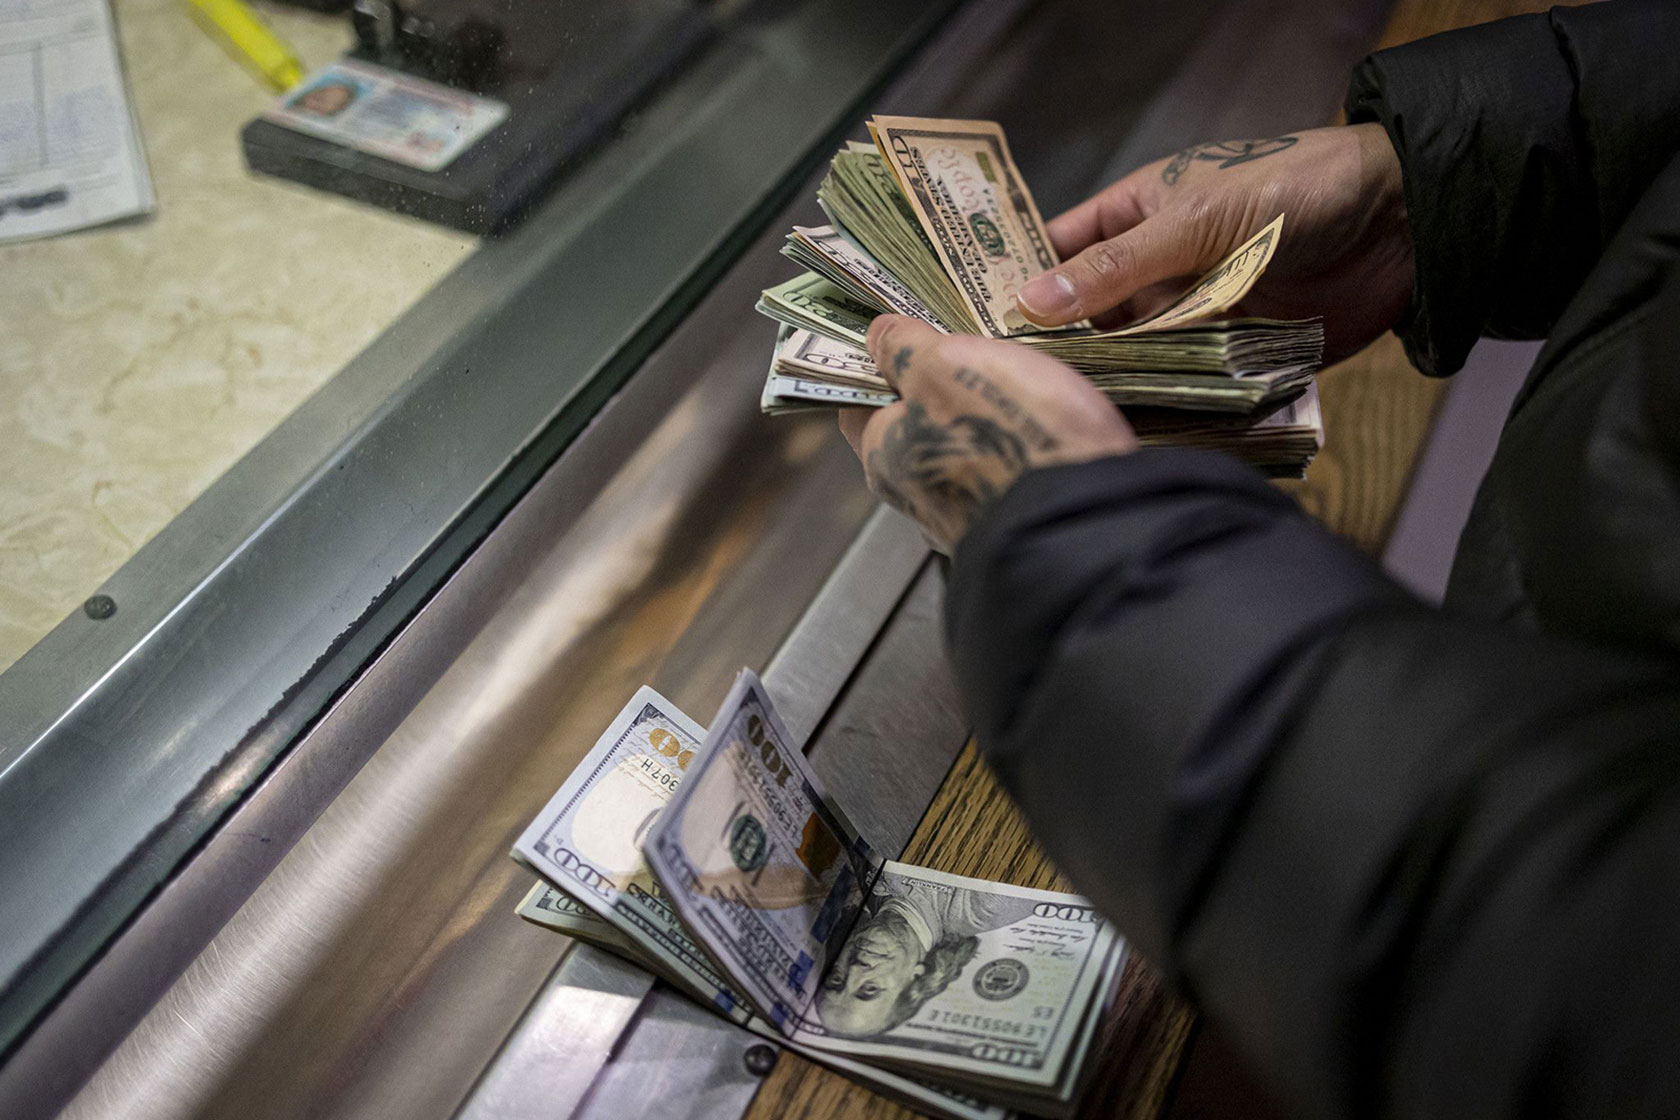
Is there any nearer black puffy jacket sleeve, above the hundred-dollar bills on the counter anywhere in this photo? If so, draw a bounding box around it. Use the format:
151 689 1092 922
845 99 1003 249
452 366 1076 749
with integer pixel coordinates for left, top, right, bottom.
948 450 1680 1120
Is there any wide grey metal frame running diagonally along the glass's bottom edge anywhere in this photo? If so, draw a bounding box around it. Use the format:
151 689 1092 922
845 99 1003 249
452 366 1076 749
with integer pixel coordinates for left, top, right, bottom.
0 0 974 1055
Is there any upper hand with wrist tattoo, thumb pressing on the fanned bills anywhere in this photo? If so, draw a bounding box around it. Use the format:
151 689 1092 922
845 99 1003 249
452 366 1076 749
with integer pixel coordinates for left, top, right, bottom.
1020 124 1413 361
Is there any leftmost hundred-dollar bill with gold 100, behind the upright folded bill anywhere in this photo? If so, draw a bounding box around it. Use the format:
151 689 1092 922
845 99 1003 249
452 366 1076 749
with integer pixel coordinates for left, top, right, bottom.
512 688 748 1023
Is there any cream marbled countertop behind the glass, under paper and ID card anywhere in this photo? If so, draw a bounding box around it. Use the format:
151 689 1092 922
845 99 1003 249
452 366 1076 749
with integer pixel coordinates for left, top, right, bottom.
0 0 477 670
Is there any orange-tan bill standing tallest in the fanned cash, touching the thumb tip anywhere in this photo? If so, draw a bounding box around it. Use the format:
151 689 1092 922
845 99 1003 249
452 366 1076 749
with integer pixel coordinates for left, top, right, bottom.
869 116 1058 338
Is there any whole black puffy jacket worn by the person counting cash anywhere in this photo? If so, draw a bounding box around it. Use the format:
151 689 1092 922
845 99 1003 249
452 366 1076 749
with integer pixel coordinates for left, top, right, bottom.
946 0 1680 1118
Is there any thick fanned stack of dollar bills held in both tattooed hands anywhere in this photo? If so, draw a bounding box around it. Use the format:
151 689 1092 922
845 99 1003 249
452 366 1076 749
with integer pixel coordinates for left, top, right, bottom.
758 116 1324 475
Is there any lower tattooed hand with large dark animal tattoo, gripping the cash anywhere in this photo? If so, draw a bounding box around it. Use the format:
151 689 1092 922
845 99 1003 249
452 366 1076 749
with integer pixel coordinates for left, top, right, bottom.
840 316 1137 554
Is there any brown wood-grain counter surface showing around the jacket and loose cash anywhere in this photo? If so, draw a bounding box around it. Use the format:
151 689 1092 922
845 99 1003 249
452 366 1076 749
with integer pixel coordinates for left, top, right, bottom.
748 0 1551 1120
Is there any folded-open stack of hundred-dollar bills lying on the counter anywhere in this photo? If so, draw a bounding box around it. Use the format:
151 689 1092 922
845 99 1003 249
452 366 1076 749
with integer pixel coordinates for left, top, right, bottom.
512 672 1126 1120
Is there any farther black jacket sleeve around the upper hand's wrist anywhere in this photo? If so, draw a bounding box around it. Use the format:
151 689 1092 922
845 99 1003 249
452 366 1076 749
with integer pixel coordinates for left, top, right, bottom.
1347 0 1680 374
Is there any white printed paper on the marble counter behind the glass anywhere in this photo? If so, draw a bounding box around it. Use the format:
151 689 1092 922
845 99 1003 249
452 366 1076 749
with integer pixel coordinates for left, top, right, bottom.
0 0 153 242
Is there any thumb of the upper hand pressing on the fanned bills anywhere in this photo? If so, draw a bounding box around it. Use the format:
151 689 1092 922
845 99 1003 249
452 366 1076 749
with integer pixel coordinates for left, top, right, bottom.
1016 218 1206 327
